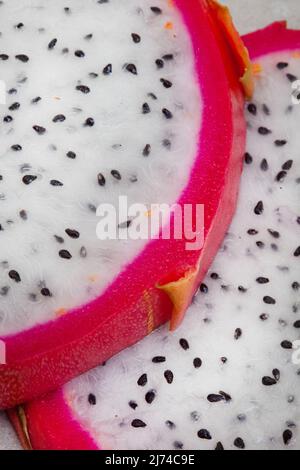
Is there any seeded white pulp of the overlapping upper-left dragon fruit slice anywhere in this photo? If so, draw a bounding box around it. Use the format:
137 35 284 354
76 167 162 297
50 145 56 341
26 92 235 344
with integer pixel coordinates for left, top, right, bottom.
0 0 201 335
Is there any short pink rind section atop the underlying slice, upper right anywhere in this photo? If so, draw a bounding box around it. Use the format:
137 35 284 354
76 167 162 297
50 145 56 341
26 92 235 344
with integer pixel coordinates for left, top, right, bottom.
243 21 300 59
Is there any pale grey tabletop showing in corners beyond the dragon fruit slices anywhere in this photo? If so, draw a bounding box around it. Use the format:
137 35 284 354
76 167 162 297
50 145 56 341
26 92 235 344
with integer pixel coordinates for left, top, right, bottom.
0 0 300 456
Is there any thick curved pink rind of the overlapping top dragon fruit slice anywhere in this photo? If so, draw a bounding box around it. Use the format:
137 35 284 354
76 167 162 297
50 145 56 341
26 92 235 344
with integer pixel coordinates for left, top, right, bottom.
0 0 246 412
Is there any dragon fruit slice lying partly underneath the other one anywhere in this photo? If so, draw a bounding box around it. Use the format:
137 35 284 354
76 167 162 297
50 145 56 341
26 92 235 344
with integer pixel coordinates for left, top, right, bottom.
14 23 300 450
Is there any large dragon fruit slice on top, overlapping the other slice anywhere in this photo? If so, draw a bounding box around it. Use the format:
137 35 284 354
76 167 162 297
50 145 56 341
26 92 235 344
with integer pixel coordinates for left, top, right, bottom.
0 0 248 408
